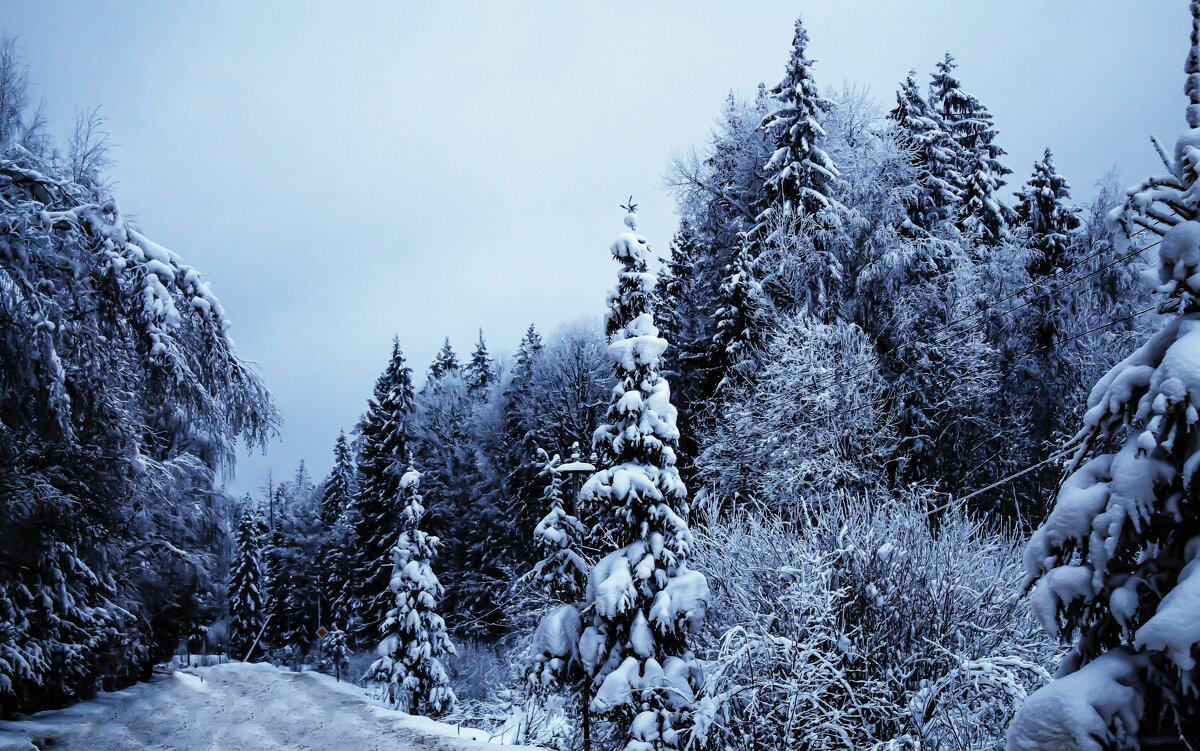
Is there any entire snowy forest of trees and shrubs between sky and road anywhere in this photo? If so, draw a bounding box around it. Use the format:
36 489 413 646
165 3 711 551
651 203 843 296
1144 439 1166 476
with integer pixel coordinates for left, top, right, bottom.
0 2 1200 751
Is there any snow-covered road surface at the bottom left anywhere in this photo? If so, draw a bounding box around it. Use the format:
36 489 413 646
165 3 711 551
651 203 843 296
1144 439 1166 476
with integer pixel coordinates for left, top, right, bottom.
0 662 514 751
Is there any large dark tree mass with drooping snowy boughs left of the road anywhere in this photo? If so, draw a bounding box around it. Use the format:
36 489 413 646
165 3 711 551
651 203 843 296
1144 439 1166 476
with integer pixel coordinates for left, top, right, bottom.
0 130 277 716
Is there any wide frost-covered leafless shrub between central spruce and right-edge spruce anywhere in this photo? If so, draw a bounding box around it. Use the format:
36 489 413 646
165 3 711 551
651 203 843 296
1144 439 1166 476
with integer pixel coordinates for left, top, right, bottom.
695 497 1054 750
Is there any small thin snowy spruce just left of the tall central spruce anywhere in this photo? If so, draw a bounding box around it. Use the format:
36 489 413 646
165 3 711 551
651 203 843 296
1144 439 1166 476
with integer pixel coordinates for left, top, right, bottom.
530 444 588 602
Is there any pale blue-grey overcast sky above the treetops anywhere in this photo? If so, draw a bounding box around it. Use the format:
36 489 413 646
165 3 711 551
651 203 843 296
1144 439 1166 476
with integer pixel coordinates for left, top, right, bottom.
0 0 1189 492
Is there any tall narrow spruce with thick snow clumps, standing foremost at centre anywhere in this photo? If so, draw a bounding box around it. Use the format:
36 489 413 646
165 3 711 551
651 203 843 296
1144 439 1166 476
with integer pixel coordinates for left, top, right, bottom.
566 211 708 751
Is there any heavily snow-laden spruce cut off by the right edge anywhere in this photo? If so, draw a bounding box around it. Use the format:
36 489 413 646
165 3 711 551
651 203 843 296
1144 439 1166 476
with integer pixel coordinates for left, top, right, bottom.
1008 11 1200 751
